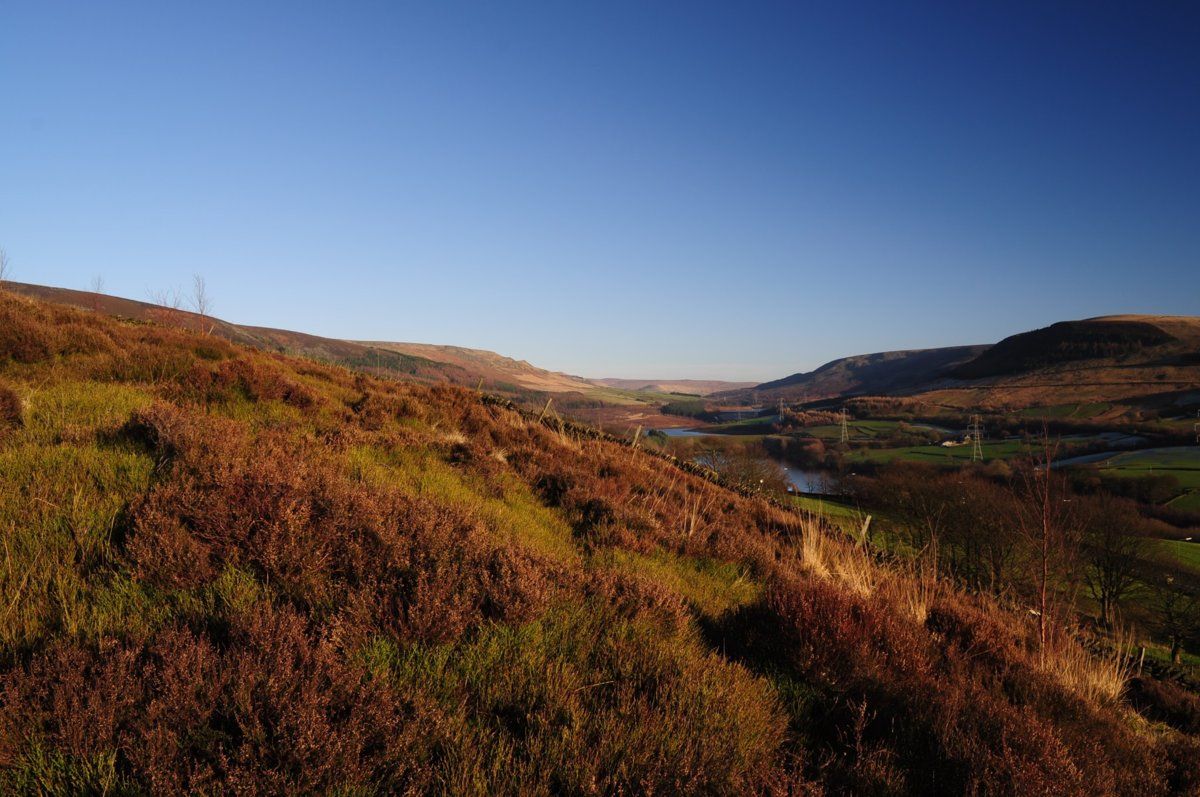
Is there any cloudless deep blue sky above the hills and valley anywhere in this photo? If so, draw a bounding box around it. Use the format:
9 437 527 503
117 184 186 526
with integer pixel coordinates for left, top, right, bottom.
0 0 1200 379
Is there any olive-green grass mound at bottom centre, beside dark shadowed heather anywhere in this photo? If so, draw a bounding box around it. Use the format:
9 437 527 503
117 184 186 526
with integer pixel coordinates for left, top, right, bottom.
360 604 784 793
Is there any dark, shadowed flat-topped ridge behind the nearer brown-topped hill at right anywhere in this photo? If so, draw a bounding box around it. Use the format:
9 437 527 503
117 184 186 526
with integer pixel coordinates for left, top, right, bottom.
721 346 988 402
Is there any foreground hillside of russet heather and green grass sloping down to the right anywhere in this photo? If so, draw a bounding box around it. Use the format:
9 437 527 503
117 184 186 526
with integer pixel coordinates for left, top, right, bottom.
0 293 1200 795
